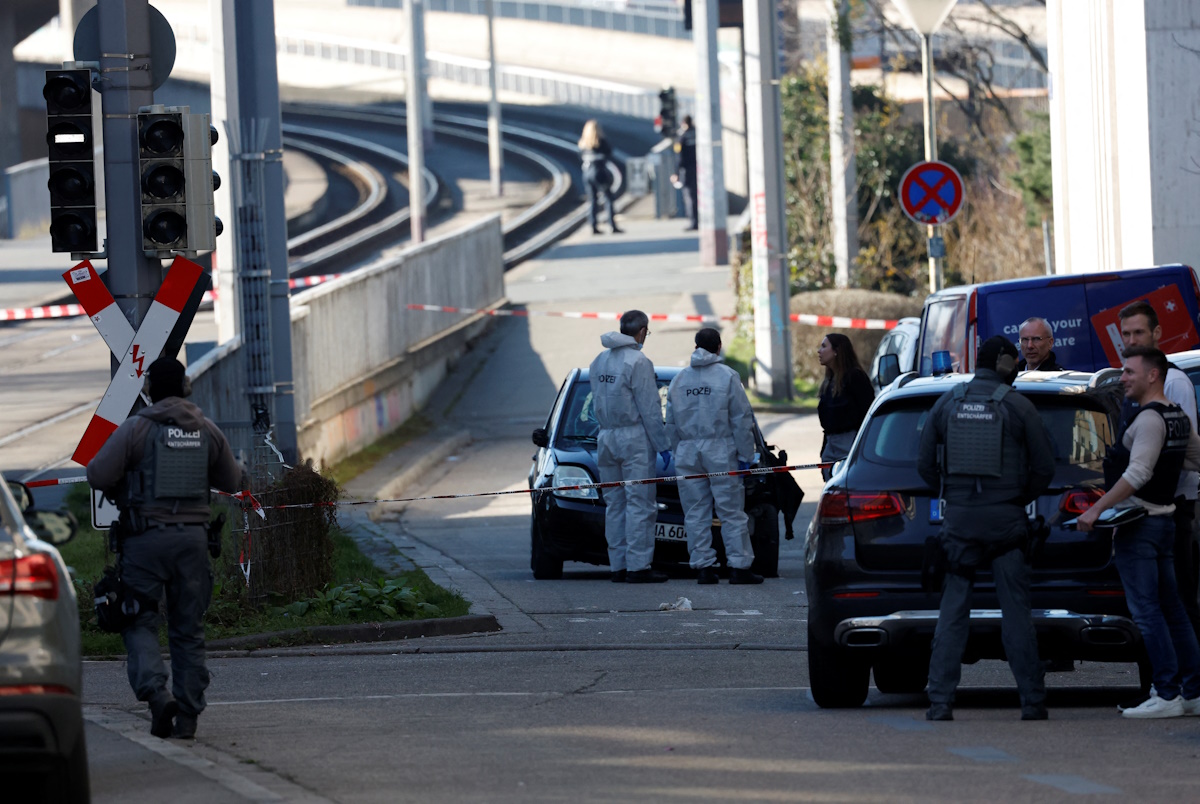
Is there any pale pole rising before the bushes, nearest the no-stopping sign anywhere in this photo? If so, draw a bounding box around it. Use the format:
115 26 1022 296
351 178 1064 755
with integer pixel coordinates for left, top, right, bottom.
826 0 858 288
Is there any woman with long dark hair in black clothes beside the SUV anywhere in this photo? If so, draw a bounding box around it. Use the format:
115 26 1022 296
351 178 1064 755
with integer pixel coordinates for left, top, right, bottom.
817 332 875 480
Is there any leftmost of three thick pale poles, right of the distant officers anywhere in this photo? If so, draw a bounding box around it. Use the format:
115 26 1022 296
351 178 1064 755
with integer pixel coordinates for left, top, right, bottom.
696 0 730 266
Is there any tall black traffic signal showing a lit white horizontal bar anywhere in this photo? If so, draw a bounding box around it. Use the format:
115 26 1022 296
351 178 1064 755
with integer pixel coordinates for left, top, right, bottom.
42 68 97 252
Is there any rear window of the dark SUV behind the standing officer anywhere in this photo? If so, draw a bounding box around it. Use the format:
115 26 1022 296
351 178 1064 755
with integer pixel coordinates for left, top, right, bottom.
858 395 1112 485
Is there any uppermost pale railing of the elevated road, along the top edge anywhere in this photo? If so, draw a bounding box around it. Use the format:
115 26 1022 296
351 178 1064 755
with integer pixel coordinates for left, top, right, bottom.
347 0 691 40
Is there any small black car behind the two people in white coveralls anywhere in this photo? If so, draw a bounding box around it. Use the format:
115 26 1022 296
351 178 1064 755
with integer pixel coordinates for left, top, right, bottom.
529 366 803 580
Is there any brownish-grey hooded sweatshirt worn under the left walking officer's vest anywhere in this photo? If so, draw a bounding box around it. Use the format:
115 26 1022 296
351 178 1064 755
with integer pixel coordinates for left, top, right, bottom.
88 396 241 524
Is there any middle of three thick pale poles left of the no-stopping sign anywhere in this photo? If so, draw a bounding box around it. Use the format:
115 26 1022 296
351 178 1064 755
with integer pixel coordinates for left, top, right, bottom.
743 0 792 398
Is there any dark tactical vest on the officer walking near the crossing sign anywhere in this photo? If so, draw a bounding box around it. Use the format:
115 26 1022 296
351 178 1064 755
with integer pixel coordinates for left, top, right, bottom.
119 421 209 510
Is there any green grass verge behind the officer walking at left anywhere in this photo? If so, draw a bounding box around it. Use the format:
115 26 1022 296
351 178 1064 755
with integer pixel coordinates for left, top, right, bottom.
59 485 470 656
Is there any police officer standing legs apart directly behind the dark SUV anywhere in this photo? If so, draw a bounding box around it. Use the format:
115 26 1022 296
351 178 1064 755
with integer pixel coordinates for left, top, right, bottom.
917 335 1055 720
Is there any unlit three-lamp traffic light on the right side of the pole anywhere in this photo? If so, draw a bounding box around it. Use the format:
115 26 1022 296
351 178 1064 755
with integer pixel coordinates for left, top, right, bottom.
138 106 221 257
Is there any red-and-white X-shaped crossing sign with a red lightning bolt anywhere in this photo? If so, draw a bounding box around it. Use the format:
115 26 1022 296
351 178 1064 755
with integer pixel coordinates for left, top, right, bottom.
62 257 204 466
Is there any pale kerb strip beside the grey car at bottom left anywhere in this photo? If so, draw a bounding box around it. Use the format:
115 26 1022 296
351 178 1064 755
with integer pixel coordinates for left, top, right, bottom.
83 704 329 804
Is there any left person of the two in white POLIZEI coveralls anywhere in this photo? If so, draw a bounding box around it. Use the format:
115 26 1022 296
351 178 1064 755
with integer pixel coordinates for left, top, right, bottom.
589 310 671 583
